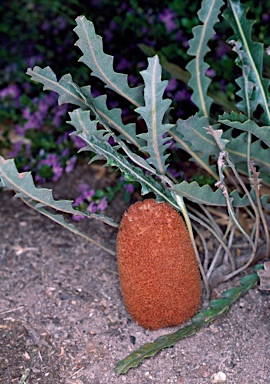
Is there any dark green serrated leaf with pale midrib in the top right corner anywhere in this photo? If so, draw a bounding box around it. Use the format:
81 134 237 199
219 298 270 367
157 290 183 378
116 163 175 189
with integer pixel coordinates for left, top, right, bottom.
223 0 270 125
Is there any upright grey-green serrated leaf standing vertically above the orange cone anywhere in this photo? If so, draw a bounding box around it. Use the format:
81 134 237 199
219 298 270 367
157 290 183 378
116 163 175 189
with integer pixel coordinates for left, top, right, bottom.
136 56 173 175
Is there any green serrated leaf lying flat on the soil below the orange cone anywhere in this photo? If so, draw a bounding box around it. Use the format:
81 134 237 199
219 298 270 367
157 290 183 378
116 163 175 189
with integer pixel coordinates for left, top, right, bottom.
115 266 259 375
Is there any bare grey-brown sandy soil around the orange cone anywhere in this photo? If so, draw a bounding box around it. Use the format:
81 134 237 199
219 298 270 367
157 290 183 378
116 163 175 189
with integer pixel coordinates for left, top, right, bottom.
0 167 270 384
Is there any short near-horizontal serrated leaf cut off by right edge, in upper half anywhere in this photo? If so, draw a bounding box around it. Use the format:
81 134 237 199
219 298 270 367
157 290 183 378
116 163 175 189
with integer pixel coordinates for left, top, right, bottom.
219 112 270 147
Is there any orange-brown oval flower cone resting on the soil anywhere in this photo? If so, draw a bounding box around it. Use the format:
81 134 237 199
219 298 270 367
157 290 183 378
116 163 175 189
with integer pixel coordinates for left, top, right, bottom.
117 199 201 329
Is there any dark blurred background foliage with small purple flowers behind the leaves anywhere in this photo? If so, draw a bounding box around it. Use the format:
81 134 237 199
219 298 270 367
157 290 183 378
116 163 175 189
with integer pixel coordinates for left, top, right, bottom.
0 0 270 192
